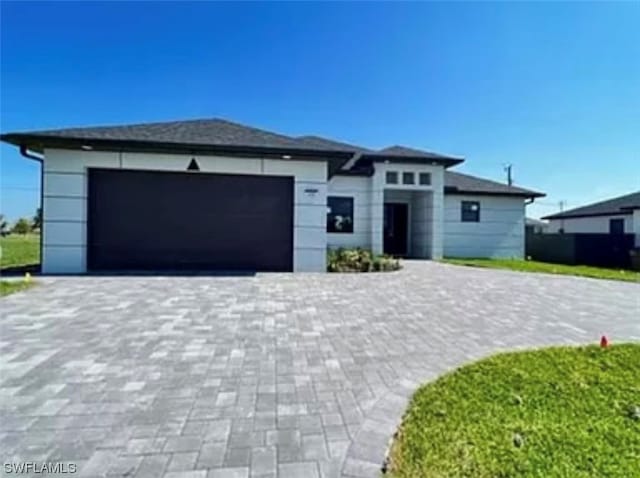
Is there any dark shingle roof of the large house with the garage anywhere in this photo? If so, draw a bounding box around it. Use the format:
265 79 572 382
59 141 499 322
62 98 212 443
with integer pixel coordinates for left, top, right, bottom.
0 118 543 197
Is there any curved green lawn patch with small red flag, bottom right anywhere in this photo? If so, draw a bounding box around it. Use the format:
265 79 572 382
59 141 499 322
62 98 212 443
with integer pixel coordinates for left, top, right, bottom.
390 344 640 478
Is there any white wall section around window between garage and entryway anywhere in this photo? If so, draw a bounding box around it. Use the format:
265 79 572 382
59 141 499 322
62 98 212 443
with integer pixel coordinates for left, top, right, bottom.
325 176 371 249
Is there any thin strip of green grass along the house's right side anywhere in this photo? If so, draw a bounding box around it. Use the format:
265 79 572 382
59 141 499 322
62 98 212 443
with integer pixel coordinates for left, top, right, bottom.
443 258 640 282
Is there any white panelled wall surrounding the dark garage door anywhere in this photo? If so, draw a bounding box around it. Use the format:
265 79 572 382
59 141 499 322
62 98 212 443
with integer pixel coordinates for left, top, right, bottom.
42 149 327 273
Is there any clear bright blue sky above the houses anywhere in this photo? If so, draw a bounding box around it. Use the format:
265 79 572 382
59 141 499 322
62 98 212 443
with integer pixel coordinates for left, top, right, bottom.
0 2 640 219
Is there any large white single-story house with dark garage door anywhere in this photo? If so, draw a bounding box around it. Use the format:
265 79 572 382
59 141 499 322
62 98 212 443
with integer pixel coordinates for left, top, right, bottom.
0 119 543 273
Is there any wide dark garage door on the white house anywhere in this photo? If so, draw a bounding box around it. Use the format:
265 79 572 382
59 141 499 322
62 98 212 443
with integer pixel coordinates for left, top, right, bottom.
87 169 293 271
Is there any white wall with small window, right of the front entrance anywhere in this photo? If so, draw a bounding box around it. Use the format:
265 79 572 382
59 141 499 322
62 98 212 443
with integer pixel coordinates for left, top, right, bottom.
444 194 525 258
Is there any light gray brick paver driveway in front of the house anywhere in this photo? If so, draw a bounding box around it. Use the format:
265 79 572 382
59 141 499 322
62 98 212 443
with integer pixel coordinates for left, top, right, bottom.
0 262 640 478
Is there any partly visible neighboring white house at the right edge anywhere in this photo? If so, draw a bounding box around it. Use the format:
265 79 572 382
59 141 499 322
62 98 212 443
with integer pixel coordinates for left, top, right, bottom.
543 191 640 241
